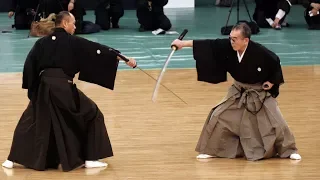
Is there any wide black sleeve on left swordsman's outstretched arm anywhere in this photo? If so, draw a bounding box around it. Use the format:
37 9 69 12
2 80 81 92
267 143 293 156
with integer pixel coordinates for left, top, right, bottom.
72 37 119 90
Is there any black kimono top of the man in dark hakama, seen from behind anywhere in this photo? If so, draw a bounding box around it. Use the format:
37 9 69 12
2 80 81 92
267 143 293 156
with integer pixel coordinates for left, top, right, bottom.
22 28 119 95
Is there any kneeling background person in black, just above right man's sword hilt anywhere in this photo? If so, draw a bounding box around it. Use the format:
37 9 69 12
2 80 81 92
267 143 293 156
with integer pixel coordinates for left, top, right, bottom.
137 0 172 32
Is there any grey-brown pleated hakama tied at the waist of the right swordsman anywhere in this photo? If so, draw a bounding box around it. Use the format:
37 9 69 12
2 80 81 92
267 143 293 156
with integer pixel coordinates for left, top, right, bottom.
196 81 297 161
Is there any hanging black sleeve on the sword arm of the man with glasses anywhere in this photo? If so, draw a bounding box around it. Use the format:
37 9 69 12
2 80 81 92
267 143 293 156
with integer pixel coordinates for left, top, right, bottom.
193 39 227 84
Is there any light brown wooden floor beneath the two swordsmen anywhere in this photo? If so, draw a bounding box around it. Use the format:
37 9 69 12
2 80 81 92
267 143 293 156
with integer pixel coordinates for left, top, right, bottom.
0 66 320 180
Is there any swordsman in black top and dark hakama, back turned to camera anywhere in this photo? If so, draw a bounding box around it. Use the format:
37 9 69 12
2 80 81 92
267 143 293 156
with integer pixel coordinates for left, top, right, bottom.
2 12 136 171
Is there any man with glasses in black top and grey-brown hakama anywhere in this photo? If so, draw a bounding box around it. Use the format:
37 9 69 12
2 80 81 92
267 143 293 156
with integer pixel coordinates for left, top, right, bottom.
172 23 301 161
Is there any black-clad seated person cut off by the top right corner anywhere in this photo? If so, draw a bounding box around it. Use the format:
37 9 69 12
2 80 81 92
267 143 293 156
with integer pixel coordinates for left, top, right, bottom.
303 0 320 30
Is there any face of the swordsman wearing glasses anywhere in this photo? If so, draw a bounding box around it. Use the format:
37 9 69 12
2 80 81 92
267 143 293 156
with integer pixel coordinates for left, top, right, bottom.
229 29 249 51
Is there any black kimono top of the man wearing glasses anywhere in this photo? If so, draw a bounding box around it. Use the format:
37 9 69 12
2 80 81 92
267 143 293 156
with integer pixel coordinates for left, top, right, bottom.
193 39 284 97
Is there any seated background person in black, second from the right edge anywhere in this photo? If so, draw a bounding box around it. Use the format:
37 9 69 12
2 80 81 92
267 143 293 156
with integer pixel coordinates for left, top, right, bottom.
253 0 291 30
